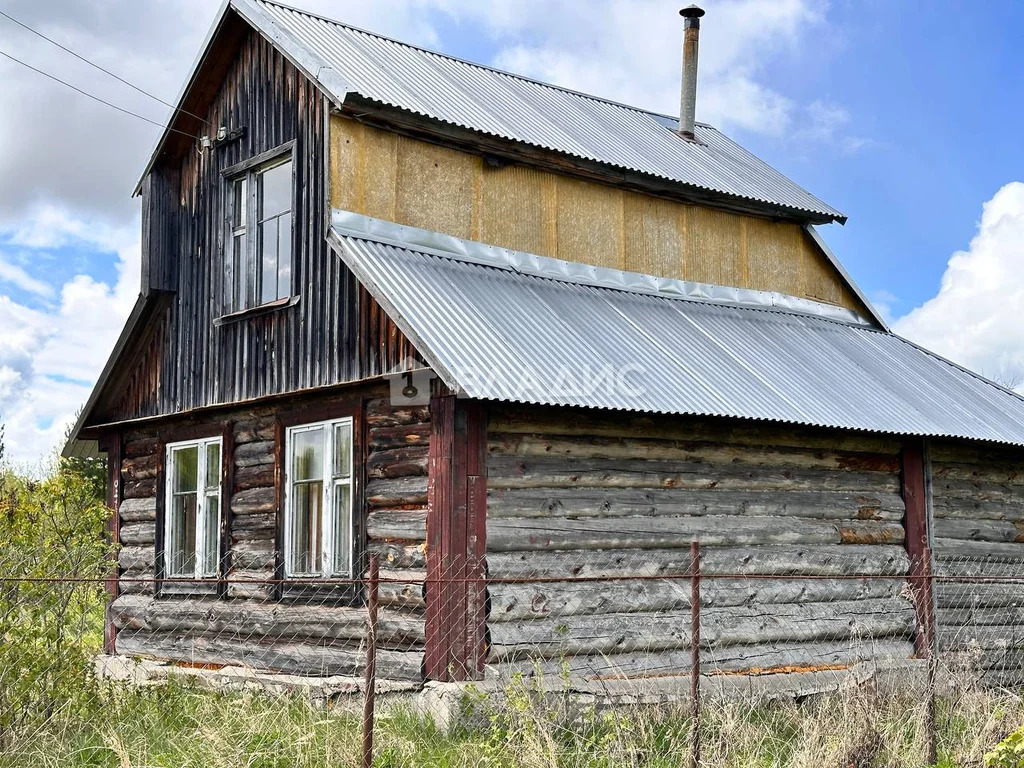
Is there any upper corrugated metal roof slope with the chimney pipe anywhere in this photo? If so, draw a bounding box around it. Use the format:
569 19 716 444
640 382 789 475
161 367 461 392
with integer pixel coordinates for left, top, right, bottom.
231 0 846 221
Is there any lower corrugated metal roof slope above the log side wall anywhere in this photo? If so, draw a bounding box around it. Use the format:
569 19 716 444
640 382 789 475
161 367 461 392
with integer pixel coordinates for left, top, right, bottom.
331 219 1024 445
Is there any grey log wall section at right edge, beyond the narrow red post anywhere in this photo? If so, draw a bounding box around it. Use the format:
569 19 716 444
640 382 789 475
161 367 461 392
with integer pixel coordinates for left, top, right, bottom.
932 441 1024 684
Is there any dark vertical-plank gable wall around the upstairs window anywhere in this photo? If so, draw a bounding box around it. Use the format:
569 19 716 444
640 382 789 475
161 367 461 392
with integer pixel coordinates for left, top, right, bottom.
90 33 414 424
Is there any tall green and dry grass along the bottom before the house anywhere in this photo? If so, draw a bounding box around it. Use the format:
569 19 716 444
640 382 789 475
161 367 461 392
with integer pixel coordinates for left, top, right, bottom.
0 682 1024 768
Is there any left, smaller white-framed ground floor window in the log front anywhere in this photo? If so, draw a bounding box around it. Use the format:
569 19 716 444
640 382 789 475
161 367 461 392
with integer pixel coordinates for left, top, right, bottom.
164 437 221 578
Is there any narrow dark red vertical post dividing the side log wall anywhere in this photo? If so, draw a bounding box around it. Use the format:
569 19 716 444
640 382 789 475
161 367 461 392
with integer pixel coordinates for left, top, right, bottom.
900 438 935 656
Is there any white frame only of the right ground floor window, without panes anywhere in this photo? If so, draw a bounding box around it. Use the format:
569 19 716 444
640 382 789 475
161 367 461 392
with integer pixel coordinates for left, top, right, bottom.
283 416 355 579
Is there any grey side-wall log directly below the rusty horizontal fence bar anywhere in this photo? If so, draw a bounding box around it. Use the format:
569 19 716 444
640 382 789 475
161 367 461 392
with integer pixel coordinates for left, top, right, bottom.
487 579 906 623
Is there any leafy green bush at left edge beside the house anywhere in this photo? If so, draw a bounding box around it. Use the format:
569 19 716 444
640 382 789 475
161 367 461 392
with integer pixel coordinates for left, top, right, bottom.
0 468 111 750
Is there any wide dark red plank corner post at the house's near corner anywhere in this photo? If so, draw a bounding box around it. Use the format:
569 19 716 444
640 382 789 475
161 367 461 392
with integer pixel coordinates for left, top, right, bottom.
426 394 486 681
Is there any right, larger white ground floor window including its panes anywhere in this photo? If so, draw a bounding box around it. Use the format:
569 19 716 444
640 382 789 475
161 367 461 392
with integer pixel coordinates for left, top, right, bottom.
285 418 353 577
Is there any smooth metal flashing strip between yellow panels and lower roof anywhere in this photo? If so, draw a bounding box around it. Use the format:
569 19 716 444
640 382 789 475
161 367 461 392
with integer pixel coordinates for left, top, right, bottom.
331 209 872 333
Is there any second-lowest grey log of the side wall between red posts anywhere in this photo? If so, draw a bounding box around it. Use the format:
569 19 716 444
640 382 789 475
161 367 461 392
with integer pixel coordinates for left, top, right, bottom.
490 598 914 660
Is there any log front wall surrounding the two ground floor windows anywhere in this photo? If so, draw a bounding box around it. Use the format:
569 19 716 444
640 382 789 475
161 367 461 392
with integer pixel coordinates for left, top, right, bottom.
111 385 430 682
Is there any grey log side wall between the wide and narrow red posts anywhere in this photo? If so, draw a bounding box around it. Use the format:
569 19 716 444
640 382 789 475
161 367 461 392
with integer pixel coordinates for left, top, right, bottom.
486 407 914 678
